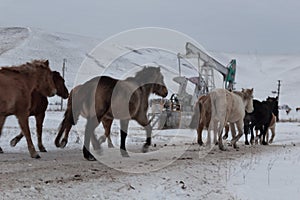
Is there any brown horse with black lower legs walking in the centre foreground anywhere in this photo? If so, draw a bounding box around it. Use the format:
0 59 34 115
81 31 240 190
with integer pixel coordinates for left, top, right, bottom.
55 67 168 160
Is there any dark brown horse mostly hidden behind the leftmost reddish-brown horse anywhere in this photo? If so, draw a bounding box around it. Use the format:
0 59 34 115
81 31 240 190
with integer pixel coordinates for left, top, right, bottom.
10 71 69 152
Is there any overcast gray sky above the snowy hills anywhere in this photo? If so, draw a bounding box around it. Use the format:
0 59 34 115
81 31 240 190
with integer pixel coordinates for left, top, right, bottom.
0 0 300 54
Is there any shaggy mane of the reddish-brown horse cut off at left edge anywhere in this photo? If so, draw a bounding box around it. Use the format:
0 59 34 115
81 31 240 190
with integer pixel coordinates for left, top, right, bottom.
0 60 48 74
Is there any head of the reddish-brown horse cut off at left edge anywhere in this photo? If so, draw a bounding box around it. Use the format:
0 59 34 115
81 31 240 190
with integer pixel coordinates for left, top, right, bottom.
34 60 57 96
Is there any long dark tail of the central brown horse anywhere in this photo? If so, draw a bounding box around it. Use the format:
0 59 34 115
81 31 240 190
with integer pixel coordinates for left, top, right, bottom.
54 88 80 147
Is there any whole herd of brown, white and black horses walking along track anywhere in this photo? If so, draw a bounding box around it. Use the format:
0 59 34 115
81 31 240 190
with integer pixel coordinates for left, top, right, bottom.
0 60 278 160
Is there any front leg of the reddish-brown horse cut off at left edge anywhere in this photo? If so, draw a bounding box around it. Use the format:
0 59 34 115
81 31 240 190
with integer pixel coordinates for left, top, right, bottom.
16 114 41 158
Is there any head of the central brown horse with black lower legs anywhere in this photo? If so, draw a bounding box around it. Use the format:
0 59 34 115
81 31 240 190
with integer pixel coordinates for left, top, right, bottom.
136 67 168 97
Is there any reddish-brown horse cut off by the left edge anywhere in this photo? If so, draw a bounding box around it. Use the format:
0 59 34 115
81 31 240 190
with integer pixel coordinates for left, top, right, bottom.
0 60 56 158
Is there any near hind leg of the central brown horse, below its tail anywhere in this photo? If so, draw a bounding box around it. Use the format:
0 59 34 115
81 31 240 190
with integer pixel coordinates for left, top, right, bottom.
83 117 99 161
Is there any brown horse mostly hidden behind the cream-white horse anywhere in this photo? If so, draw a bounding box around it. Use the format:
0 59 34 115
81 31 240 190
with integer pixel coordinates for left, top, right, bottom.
189 95 229 146
